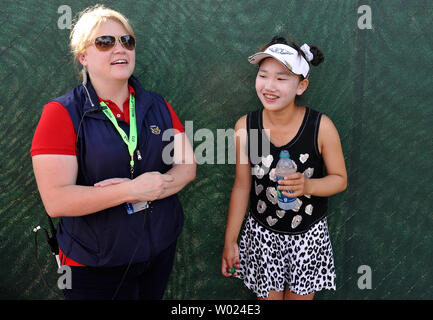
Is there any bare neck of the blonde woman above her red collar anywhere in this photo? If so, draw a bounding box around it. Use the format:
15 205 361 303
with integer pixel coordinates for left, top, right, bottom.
92 79 129 111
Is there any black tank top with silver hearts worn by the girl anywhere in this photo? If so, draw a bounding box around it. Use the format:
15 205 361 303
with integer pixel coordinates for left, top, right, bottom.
247 107 328 234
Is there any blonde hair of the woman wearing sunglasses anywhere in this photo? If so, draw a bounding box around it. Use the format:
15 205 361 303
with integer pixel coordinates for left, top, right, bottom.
69 4 135 62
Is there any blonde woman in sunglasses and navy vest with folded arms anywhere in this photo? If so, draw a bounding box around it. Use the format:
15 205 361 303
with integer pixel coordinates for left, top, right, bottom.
31 6 196 299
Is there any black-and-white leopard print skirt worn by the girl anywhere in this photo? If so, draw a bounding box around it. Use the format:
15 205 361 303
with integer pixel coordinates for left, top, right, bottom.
237 215 336 297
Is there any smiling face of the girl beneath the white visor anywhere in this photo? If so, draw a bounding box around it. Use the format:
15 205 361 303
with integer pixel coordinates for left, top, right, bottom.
256 58 308 111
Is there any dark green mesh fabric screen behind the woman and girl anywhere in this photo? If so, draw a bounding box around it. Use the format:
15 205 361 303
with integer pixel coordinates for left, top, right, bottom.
0 0 433 299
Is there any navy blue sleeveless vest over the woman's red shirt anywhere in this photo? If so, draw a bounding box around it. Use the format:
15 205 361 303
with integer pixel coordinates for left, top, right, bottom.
55 76 184 267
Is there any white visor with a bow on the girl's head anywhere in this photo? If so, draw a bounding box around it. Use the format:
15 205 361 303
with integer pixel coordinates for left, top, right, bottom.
248 43 312 78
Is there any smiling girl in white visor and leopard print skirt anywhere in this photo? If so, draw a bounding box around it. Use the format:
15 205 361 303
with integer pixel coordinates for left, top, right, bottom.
221 37 347 300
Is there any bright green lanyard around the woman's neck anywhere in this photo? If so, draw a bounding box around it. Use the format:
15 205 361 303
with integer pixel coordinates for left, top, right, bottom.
100 93 137 179
